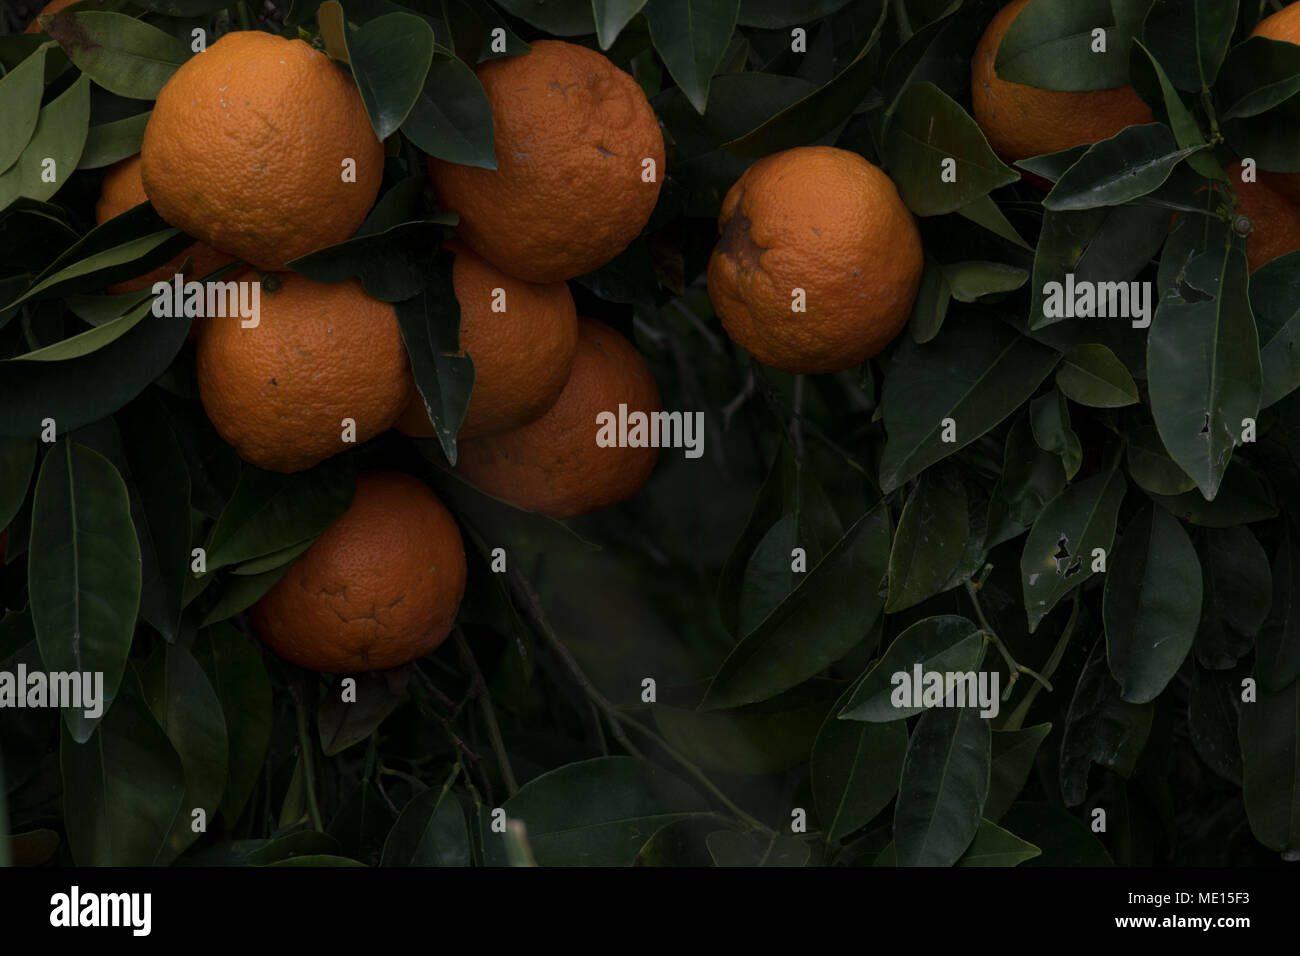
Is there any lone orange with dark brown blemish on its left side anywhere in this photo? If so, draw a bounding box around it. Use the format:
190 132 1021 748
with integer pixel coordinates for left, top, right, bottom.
709 146 924 372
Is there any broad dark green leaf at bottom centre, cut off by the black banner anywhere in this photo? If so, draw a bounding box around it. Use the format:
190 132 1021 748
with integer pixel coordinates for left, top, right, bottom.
484 757 706 866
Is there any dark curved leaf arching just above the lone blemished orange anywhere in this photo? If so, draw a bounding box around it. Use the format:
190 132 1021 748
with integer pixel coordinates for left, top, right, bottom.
723 0 888 156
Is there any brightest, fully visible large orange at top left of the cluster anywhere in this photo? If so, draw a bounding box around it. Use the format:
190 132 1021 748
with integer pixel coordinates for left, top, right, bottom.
140 30 384 269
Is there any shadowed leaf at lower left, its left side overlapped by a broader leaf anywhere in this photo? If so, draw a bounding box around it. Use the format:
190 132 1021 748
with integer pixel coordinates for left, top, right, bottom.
140 644 228 861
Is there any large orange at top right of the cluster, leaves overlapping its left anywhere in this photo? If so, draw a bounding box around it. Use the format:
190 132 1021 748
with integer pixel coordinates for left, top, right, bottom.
429 40 664 282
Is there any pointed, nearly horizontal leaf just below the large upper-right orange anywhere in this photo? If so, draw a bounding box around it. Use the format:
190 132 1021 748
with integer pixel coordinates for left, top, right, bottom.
1043 122 1205 211
